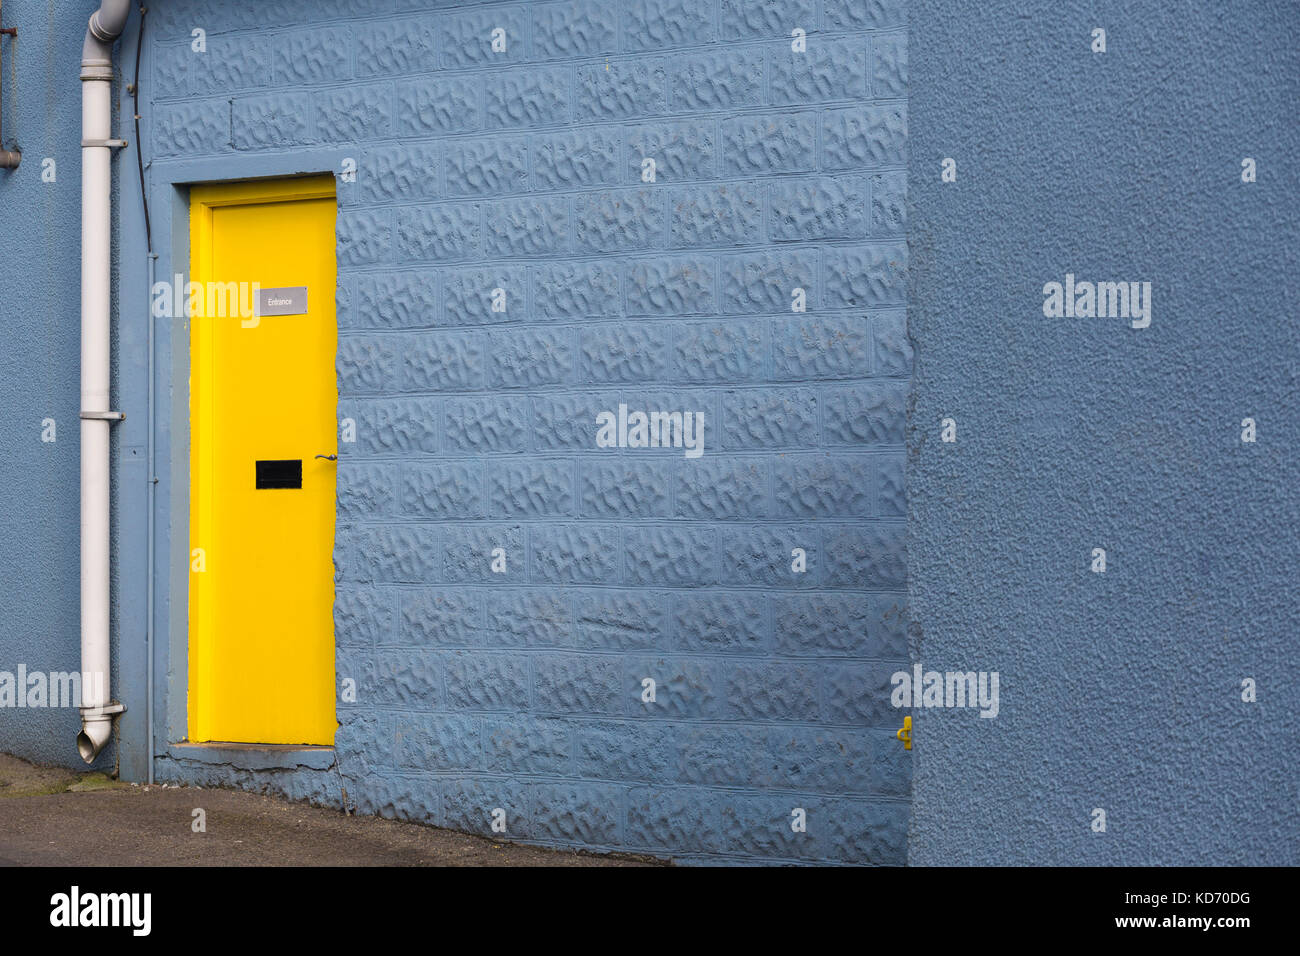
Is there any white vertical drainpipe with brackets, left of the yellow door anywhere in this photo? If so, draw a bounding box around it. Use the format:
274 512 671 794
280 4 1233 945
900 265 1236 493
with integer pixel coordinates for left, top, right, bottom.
77 0 130 763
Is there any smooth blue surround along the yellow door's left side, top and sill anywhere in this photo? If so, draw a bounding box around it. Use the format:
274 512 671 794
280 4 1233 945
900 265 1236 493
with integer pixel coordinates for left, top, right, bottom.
112 145 356 780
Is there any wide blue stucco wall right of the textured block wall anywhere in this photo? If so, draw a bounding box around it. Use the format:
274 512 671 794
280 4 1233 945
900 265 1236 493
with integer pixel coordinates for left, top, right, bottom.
907 0 1300 865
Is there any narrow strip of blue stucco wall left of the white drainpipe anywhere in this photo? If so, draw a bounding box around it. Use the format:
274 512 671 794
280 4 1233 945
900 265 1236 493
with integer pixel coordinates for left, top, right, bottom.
0 0 121 769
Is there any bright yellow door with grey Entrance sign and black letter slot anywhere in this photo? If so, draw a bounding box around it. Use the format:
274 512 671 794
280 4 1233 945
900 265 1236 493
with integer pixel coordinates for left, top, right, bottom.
185 176 338 745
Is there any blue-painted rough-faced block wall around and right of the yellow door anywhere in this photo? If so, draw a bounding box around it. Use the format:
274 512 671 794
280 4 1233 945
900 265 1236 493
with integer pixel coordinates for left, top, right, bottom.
147 0 911 864
